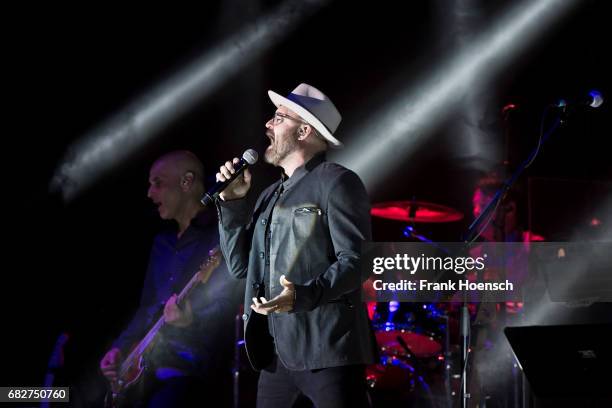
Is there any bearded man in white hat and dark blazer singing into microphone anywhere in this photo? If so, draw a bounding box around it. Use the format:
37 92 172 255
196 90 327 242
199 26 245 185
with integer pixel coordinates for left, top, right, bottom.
217 84 376 408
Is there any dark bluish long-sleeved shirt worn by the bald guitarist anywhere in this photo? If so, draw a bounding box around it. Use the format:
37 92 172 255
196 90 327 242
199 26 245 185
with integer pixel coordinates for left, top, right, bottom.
113 211 240 375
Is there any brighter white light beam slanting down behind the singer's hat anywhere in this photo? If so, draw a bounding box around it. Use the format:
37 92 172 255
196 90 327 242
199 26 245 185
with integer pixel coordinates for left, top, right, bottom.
331 0 577 187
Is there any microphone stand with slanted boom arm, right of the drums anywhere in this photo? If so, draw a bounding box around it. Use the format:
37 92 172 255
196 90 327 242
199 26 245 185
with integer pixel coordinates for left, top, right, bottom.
460 110 564 408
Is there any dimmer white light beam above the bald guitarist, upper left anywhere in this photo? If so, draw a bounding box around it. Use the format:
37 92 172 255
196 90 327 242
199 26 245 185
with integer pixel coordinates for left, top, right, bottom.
50 0 328 201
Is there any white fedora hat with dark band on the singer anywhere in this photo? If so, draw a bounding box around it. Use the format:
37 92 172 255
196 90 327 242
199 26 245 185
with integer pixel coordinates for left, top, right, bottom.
268 83 342 147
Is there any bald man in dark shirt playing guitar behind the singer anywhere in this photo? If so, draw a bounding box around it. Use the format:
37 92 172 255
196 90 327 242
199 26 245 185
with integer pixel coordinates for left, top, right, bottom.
100 151 241 407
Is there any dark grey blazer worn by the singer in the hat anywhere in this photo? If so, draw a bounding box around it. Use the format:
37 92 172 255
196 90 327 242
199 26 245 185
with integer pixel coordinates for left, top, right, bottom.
218 155 376 370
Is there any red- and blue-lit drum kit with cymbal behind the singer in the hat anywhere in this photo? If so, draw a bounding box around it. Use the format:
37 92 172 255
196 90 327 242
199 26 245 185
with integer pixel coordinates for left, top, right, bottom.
366 200 463 407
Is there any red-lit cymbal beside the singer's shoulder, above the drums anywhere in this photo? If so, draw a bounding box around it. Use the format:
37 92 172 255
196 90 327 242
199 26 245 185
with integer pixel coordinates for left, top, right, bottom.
370 201 463 223
